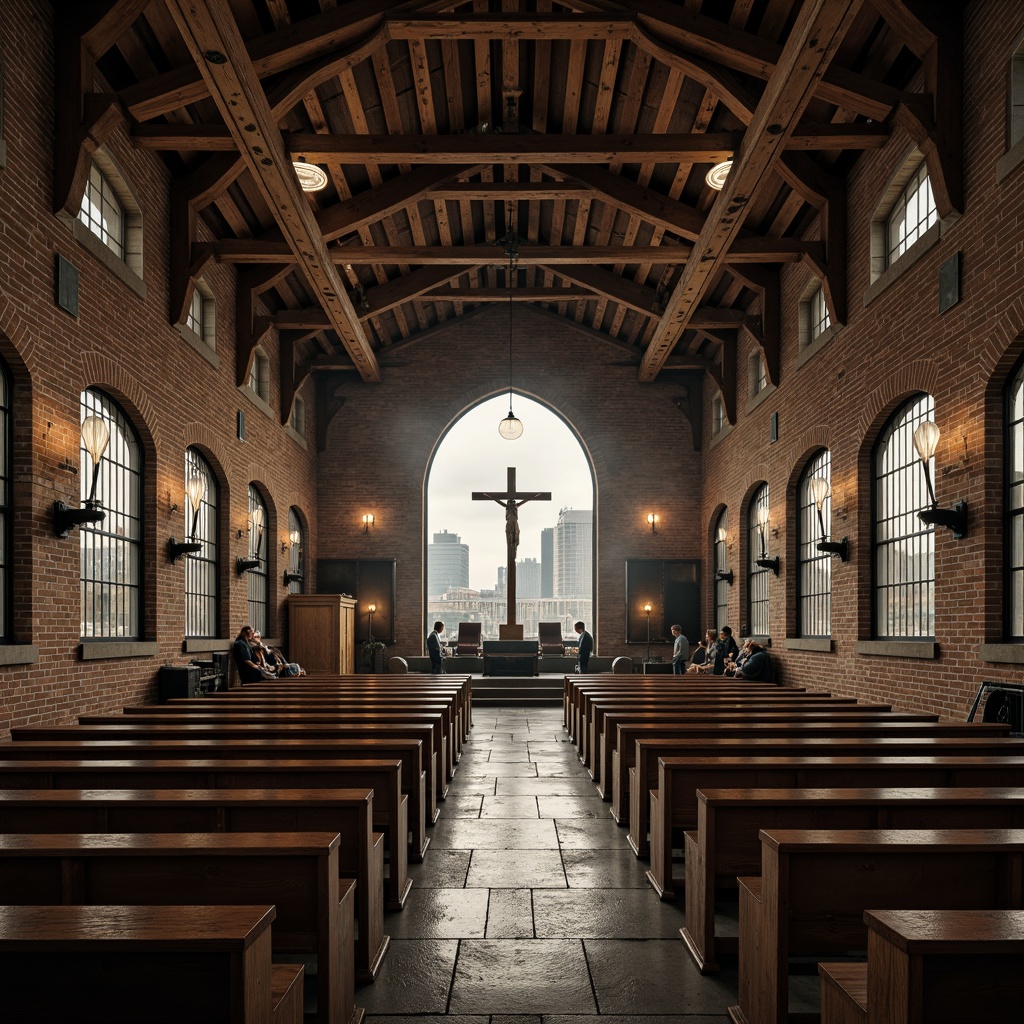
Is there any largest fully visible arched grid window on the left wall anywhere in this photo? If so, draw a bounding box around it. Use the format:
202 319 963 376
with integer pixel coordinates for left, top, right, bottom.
79 388 142 640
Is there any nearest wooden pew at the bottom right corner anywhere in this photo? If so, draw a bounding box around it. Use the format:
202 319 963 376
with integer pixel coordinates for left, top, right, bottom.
818 910 1024 1024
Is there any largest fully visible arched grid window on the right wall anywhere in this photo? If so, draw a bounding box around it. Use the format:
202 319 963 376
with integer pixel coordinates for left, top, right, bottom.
873 394 935 640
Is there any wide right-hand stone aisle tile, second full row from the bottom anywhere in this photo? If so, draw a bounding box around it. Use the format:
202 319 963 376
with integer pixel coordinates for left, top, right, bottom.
532 892 685 937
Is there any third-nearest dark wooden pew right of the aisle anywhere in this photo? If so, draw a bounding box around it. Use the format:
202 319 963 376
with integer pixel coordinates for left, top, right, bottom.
673 786 1024 974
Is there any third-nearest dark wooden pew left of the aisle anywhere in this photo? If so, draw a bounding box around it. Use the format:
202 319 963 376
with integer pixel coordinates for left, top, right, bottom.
0 790 391 983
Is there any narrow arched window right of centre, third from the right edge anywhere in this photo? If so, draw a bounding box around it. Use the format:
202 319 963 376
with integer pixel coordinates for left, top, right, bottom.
797 449 831 637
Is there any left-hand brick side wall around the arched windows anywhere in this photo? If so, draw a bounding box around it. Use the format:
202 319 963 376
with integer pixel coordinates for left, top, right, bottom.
0 0 316 734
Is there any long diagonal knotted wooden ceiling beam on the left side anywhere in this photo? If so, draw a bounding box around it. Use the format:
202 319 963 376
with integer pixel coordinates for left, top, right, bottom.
167 0 380 381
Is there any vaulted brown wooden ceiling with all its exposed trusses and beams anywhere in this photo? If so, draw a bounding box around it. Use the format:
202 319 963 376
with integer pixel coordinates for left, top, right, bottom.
56 0 963 418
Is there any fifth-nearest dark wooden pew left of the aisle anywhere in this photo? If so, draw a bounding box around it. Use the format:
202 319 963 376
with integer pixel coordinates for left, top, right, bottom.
0 727 430 862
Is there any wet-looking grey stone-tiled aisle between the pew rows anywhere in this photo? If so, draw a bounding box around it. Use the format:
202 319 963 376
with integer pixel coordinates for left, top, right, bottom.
355 706 736 1024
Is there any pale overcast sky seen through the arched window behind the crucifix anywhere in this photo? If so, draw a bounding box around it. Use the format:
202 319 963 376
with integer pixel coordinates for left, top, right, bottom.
427 394 594 590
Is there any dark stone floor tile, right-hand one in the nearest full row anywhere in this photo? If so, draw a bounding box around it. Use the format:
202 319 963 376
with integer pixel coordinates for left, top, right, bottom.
584 936 737 1015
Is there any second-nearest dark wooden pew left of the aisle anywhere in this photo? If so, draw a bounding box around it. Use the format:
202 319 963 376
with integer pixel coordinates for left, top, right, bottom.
0 833 364 1024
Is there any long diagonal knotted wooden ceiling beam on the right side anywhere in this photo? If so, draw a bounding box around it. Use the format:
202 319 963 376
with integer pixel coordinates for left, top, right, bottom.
640 0 863 381
